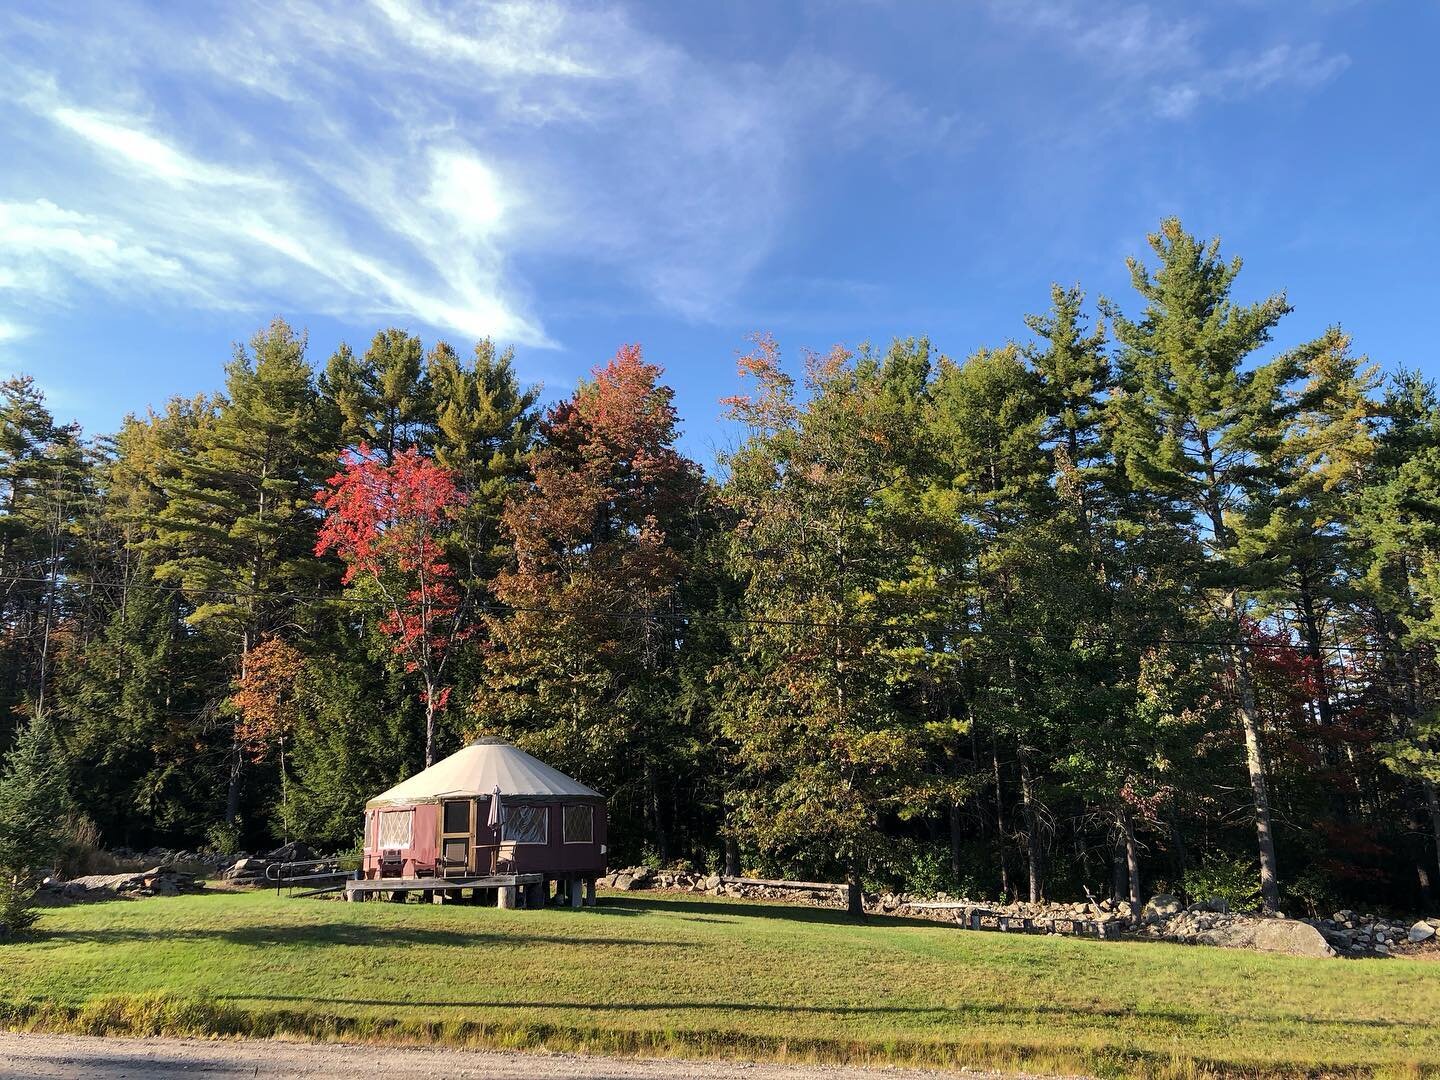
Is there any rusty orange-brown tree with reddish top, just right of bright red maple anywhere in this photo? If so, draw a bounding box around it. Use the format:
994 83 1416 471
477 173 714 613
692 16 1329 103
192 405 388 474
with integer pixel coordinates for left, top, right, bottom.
475 346 706 857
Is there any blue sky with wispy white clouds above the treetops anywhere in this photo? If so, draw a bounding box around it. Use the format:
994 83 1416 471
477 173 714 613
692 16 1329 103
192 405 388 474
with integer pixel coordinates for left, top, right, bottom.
0 0 1440 464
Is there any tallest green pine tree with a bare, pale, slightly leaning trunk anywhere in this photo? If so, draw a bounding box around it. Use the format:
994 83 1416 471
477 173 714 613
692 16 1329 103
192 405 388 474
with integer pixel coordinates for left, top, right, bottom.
1109 219 1297 910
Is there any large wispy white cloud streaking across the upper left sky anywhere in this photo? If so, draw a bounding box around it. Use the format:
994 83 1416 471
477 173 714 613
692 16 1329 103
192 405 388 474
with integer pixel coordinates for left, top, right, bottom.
0 0 949 344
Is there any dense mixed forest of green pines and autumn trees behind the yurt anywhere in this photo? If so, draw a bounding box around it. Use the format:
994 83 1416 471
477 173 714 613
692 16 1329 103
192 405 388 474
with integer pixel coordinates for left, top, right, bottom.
0 219 1440 914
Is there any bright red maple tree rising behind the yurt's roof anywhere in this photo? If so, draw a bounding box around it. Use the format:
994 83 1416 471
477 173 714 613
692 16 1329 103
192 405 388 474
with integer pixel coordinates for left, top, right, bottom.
315 446 475 765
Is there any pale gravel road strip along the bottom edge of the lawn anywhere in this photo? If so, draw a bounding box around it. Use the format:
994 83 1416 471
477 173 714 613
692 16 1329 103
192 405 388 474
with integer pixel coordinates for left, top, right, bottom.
0 1031 1059 1080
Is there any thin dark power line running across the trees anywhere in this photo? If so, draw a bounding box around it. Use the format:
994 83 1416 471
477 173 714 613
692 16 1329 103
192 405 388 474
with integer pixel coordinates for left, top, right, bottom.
0 576 1411 654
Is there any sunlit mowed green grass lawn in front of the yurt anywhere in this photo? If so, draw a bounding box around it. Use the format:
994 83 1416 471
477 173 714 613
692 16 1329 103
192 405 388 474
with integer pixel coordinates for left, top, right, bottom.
0 893 1440 1076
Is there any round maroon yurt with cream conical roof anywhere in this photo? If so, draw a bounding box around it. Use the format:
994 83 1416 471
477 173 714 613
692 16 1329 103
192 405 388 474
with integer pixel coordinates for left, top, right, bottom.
361 739 606 887
